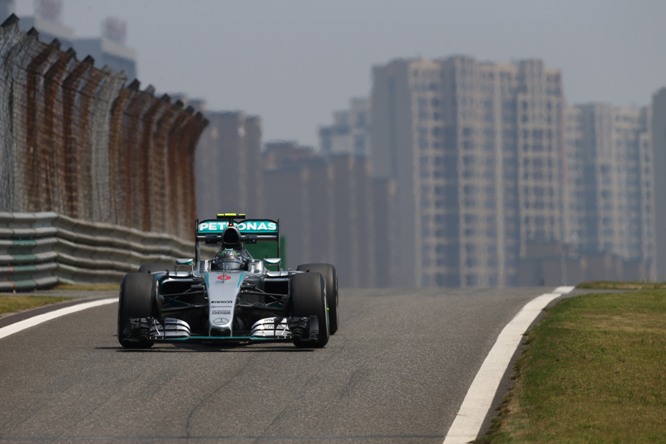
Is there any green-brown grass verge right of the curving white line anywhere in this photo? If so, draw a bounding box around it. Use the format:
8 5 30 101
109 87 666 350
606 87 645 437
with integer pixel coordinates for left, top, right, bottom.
476 289 666 443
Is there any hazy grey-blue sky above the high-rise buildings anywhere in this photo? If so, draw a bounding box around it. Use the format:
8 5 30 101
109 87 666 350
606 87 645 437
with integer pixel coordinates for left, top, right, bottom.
16 0 666 145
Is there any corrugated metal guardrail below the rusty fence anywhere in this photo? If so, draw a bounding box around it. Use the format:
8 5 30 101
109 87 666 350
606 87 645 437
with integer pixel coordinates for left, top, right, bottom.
0 212 194 291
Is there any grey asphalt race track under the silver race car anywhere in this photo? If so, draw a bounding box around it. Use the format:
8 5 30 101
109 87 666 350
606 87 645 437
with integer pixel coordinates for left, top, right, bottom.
0 288 564 443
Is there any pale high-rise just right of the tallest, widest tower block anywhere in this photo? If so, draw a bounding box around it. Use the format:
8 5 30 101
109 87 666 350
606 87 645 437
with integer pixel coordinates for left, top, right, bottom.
563 103 656 280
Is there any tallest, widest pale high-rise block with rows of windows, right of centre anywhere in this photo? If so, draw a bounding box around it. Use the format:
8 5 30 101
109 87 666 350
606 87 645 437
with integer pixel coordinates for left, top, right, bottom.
372 56 564 287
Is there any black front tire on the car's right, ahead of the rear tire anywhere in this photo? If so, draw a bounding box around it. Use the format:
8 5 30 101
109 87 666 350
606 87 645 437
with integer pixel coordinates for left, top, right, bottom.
289 273 329 348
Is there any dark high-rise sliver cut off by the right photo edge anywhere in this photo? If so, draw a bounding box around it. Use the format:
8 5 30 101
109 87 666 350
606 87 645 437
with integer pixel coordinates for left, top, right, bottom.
650 88 666 282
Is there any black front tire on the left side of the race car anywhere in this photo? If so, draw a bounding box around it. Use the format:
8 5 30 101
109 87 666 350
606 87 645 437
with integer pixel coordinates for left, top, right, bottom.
118 273 158 348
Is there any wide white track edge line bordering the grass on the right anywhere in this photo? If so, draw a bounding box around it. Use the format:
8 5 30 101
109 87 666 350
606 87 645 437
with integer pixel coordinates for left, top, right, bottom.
444 287 574 444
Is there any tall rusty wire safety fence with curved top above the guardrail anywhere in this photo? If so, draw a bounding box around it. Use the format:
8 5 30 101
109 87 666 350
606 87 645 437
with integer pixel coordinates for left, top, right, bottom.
0 16 207 241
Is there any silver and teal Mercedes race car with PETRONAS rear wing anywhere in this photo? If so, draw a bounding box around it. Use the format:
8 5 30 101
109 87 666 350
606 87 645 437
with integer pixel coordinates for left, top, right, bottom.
118 213 338 348
